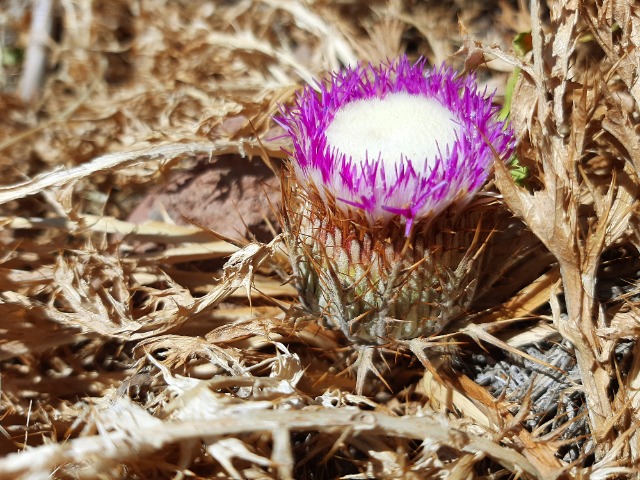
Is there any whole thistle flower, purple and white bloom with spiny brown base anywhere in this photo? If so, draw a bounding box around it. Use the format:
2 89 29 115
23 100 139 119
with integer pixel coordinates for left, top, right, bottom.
278 57 514 343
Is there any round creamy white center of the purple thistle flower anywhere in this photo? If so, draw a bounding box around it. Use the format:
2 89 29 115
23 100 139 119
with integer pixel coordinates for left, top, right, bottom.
326 92 459 176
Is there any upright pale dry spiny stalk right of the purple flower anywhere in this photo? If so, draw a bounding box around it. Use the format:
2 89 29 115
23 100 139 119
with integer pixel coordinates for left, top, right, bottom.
496 0 633 458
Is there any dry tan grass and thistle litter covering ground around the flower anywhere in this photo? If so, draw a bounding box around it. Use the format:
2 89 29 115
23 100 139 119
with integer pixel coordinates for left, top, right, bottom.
0 0 640 479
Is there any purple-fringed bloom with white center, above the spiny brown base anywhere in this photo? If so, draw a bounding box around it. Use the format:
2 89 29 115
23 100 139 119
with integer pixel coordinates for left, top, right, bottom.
277 56 515 234
